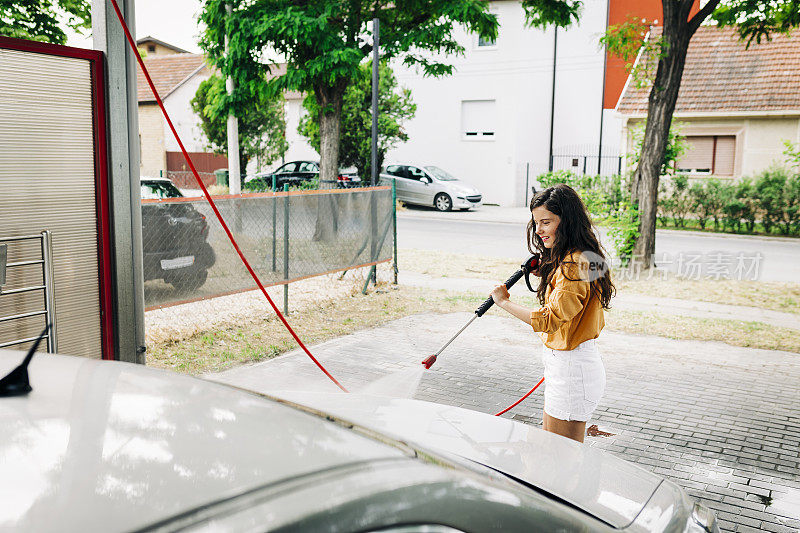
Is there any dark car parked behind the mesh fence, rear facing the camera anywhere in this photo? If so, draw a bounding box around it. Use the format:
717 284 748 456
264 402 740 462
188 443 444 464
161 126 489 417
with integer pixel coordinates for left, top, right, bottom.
141 178 216 291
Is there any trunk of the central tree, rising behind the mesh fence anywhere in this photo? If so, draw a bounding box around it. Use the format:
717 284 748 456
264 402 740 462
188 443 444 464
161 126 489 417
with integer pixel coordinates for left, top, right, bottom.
313 80 347 241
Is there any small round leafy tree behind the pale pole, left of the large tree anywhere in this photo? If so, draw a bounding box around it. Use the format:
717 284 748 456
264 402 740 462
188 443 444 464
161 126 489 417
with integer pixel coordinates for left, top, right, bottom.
191 74 289 177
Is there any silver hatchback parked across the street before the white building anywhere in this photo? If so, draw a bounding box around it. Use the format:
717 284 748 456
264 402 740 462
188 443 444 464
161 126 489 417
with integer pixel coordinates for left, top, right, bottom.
381 164 483 211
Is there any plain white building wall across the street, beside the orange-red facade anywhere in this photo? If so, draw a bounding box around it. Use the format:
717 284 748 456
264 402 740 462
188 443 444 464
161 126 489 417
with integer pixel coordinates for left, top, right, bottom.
387 0 608 205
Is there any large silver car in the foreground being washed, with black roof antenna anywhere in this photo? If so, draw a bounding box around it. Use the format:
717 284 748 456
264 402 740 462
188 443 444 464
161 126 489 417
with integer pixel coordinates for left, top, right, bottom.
0 350 718 533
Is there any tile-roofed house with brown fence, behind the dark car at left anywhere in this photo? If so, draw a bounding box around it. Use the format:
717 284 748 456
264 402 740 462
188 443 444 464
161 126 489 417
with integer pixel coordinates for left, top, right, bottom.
136 50 228 189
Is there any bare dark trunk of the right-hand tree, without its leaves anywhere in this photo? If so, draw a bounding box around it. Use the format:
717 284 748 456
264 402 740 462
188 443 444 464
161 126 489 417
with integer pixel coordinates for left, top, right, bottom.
631 5 694 269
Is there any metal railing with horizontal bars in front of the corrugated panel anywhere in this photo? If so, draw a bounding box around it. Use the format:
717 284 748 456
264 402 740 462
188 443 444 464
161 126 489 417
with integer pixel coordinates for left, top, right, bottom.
0 230 58 353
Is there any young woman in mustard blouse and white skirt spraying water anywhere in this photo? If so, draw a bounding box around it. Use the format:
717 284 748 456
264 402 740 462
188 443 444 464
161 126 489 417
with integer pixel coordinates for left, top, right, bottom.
492 184 614 442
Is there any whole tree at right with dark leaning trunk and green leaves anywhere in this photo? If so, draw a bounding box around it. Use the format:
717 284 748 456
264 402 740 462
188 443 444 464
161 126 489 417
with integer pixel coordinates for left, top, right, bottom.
605 0 800 268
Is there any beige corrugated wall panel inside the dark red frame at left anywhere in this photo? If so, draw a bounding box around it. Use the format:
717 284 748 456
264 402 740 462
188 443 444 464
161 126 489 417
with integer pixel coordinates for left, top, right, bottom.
0 49 101 358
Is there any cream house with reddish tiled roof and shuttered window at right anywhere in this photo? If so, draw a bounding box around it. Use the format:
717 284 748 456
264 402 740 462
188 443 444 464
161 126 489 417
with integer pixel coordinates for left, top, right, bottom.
616 26 800 179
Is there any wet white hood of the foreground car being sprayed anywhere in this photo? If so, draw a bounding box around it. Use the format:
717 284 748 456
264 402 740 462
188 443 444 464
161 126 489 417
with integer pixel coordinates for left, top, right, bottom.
273 391 663 528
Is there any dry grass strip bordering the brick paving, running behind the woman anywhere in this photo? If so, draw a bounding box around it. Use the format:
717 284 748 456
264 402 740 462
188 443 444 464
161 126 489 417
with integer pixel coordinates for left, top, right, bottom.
147 276 800 374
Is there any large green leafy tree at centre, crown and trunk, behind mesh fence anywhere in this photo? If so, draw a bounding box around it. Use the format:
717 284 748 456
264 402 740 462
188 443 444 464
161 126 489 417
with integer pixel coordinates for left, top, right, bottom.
200 0 581 238
